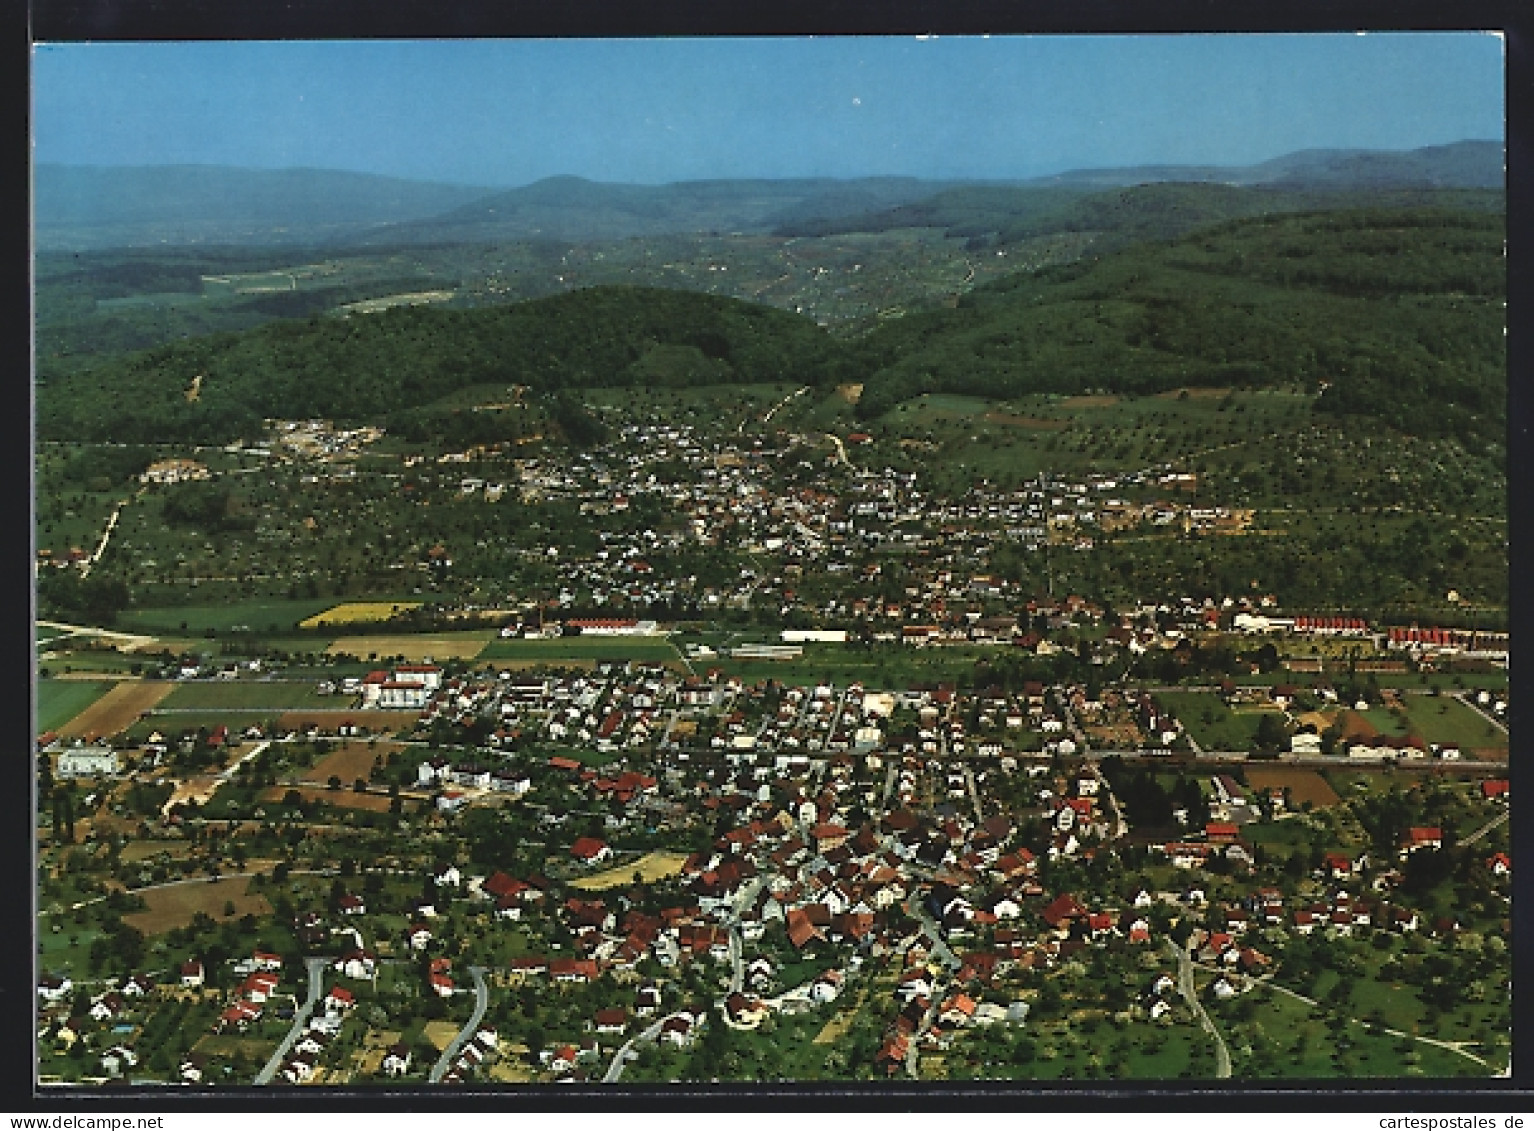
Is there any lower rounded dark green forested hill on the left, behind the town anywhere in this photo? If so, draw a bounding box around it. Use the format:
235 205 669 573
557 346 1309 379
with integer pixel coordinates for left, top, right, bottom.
37 287 859 443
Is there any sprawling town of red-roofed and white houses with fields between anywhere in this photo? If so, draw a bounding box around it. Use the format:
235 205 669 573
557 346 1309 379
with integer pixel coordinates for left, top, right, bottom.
38 390 1511 1085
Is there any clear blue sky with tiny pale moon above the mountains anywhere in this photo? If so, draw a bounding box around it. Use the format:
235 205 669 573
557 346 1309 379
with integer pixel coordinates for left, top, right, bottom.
32 32 1503 186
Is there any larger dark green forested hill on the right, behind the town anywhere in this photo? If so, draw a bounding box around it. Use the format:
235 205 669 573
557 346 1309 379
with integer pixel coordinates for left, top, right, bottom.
856 209 1506 442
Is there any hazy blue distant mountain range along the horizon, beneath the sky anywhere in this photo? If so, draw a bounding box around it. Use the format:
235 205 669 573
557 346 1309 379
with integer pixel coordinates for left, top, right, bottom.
34 141 1505 252
